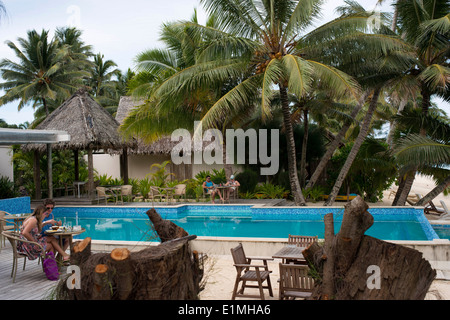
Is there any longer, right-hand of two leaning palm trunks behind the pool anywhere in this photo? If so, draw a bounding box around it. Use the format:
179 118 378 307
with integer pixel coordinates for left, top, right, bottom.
324 87 381 206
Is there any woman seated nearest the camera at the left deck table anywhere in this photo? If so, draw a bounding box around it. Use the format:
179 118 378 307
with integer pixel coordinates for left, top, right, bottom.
17 205 70 261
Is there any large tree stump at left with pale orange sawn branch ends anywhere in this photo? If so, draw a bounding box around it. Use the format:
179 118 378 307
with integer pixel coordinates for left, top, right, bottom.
56 209 203 300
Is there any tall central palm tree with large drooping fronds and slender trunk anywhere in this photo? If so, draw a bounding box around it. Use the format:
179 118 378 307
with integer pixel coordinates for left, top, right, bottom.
141 0 370 205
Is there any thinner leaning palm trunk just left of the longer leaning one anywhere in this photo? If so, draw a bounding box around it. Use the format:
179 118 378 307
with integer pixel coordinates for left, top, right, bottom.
305 91 369 190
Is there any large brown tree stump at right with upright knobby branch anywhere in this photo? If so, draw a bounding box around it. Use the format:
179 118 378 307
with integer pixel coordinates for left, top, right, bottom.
304 197 436 300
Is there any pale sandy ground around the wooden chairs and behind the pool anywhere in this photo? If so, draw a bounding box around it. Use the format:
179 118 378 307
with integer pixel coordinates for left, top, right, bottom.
200 175 450 300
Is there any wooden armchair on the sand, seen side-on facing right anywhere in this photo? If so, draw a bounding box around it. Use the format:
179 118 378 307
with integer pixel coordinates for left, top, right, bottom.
231 243 273 300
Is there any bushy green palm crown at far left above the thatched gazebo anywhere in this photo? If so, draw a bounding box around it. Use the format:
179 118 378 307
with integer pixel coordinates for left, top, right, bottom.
0 30 88 115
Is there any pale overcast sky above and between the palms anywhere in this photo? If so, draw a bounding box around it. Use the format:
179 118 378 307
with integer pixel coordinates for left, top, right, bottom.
0 0 450 124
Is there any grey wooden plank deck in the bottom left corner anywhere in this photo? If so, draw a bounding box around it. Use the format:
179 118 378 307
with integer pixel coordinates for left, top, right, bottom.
0 241 62 300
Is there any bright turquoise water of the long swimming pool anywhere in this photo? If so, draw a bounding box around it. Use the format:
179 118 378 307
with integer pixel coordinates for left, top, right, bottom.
54 205 439 241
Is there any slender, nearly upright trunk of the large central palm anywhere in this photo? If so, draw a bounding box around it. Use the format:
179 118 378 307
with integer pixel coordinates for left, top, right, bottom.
280 86 306 206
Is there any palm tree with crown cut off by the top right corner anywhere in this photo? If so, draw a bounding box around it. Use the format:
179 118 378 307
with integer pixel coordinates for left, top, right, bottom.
393 0 450 205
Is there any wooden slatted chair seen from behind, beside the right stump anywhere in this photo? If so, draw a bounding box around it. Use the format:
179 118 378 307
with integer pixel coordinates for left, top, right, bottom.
279 263 314 300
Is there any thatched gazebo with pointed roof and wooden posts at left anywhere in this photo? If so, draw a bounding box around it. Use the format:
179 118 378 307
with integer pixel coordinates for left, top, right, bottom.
23 89 132 196
